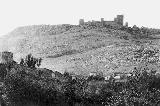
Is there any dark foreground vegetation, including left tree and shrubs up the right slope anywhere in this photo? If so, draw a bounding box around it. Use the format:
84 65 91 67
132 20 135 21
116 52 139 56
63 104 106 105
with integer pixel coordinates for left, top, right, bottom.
1 45 160 106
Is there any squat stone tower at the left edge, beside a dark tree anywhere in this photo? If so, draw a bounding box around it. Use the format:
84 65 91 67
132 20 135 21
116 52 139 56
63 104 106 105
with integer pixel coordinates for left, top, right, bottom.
0 51 13 64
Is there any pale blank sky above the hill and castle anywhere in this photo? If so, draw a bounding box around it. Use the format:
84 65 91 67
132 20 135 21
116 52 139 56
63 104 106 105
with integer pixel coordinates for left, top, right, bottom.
0 0 160 36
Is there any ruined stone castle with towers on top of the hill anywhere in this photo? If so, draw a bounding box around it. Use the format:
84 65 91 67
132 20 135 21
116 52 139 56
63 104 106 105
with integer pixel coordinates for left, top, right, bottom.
79 15 128 26
